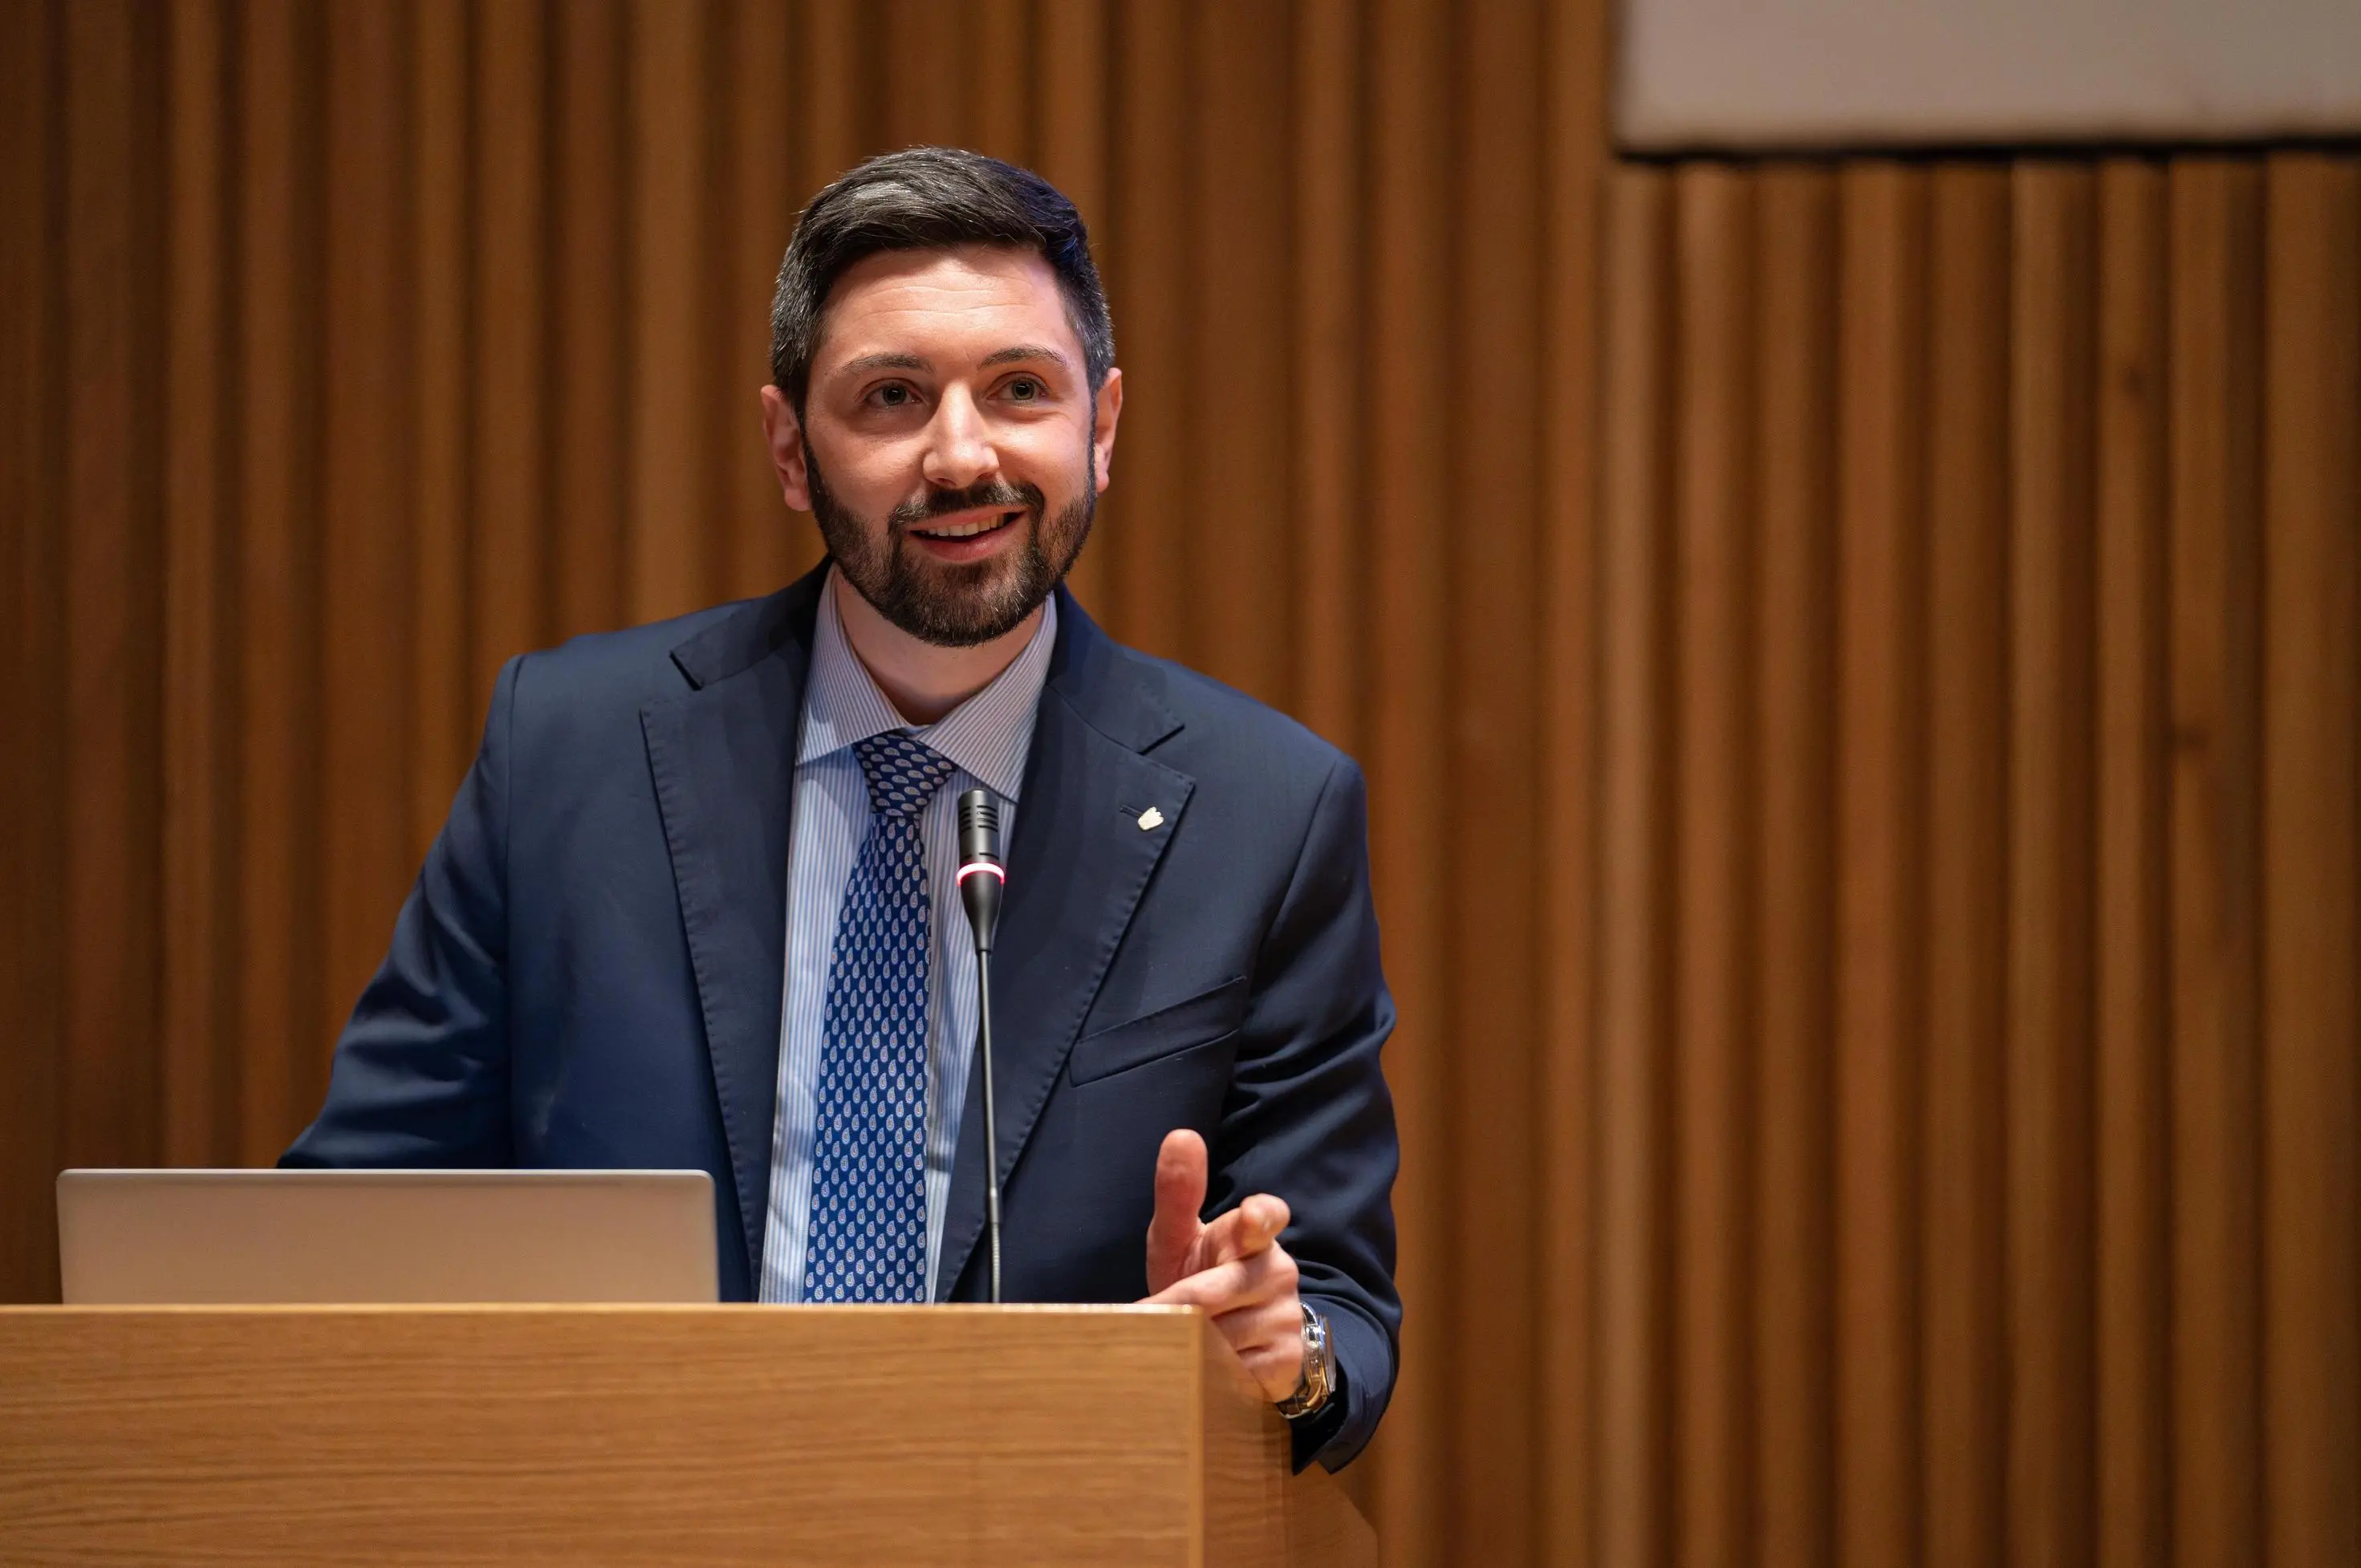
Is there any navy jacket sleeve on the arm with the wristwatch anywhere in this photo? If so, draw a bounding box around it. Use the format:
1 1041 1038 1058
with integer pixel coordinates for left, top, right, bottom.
1206 758 1403 1468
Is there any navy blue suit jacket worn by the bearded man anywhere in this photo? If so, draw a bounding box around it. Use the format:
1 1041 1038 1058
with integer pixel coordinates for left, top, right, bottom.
283 569 1400 1466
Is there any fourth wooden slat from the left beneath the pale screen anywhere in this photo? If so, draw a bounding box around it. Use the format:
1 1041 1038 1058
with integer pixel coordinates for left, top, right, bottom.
1835 163 1927 1568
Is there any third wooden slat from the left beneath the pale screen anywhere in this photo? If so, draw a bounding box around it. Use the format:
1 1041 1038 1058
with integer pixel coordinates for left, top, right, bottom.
1754 168 1837 1568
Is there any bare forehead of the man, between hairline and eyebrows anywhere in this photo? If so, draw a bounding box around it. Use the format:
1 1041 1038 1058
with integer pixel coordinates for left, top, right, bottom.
812 246 1081 376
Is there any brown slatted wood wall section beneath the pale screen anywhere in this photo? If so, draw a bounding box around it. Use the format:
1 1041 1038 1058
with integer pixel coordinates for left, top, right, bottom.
1595 153 2361 1568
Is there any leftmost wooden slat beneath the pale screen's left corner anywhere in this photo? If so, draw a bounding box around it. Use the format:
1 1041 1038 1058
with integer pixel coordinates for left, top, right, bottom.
1594 168 1672 1568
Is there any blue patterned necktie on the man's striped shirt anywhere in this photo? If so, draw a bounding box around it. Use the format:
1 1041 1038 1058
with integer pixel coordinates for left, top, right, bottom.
803 729 954 1301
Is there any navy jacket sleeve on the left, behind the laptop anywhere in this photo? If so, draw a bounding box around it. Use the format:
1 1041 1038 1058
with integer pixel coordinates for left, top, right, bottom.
278 659 522 1167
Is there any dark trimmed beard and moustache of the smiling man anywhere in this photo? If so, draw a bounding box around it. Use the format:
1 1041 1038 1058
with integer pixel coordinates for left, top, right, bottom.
803 441 1098 647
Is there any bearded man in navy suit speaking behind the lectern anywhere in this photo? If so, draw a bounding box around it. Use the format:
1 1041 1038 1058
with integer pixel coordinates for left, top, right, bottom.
286 148 1400 1468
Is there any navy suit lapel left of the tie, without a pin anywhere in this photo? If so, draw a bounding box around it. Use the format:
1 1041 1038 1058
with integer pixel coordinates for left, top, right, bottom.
640 567 824 1292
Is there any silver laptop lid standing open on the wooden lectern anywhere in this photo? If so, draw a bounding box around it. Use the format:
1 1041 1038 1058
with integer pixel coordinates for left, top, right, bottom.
57 1172 720 1306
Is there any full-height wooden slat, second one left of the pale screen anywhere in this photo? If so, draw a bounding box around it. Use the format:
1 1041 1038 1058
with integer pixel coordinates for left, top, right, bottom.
1454 0 1544 1563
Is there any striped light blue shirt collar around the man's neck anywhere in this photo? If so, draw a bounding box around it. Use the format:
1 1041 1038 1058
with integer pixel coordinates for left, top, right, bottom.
795 567 1058 801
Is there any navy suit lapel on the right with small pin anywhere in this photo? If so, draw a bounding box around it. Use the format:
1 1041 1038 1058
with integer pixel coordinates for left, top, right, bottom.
935 591 1195 1299
